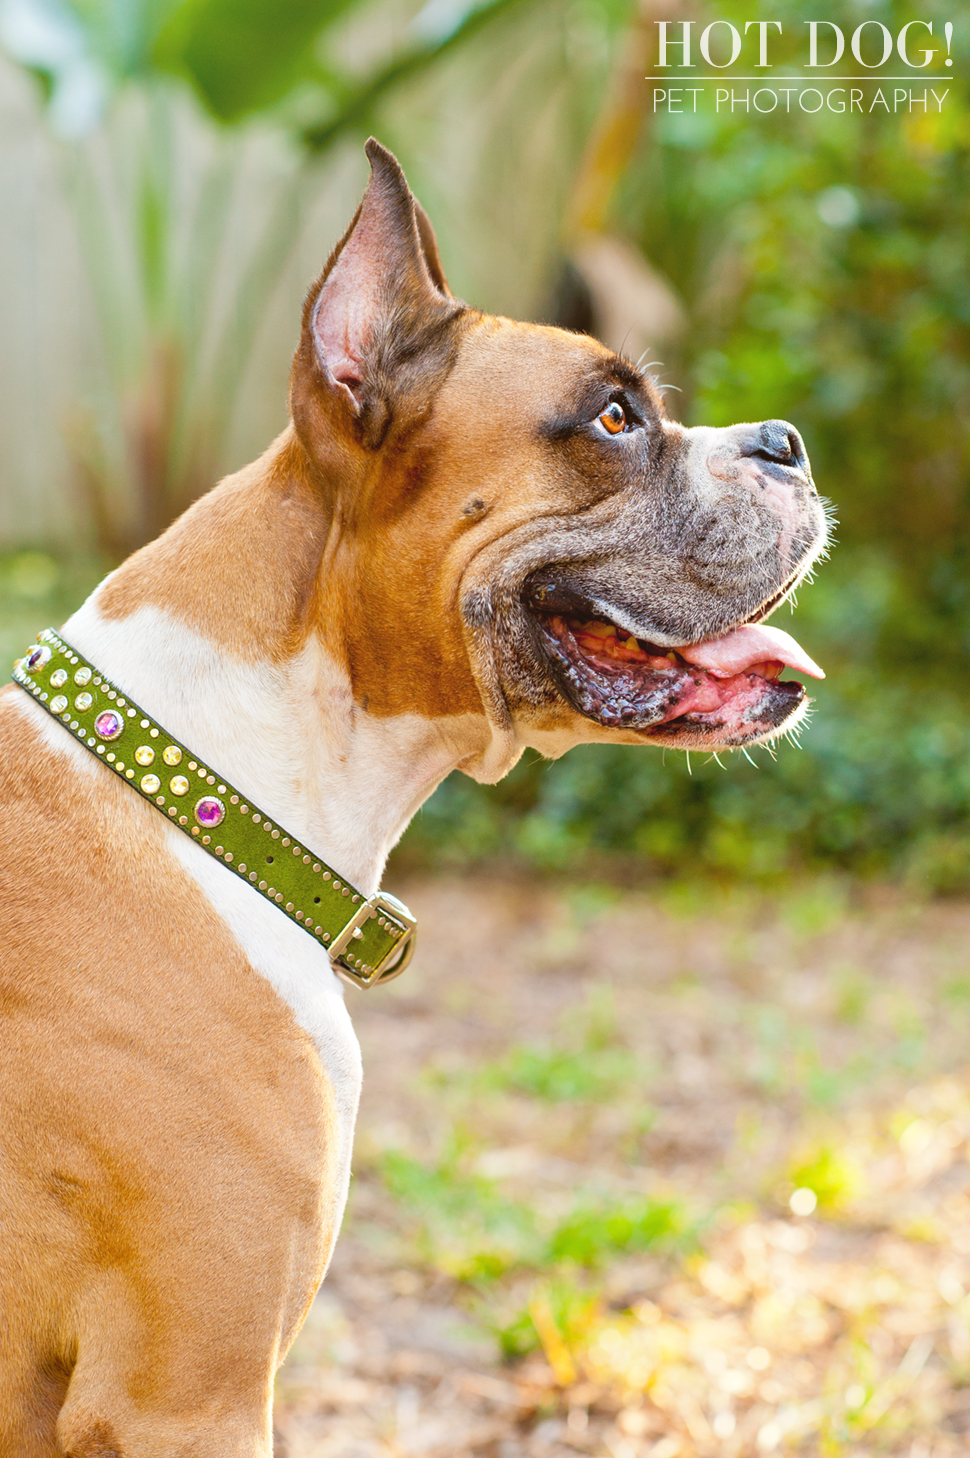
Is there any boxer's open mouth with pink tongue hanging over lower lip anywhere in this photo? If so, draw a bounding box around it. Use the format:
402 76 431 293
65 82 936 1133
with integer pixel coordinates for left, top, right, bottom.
534 612 824 748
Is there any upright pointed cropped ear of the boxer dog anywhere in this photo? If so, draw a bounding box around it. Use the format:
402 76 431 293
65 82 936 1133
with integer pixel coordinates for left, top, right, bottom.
293 137 462 448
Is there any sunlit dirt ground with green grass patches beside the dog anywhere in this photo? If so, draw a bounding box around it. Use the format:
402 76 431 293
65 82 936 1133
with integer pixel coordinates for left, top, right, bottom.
269 878 970 1458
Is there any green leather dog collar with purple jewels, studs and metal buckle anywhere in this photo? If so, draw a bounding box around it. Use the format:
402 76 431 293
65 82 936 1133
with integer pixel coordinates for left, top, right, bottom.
13 628 417 987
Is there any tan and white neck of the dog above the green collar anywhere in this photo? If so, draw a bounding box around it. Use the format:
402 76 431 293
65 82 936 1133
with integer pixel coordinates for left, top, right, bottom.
64 432 493 894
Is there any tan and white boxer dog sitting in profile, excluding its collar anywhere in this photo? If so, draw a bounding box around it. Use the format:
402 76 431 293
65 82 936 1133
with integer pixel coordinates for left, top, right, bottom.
0 141 826 1458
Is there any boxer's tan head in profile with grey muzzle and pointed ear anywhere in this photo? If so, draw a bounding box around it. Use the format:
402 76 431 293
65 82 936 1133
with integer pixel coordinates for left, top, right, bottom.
290 141 827 777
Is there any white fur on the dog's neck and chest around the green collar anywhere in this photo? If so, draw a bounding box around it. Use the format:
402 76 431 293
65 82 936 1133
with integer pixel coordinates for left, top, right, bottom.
54 593 493 1265
